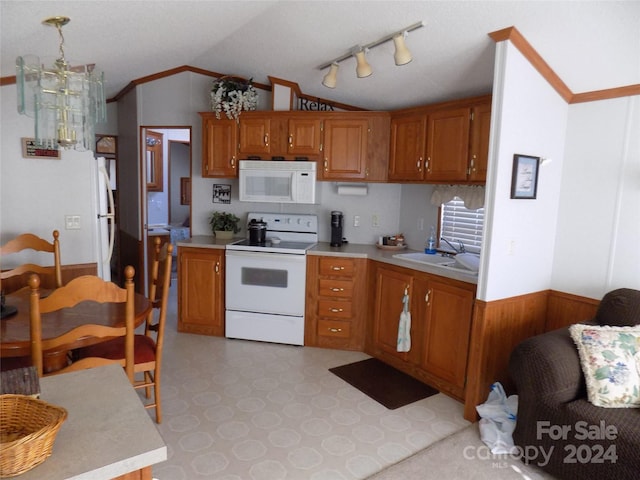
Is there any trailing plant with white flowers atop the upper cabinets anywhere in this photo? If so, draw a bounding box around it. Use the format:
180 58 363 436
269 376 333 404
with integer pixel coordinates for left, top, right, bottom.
211 77 258 120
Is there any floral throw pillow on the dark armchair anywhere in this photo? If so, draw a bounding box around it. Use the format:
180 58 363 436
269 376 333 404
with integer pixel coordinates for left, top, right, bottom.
569 324 640 408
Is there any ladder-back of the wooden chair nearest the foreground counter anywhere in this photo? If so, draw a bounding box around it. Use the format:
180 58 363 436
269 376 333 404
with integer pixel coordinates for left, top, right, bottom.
29 266 135 384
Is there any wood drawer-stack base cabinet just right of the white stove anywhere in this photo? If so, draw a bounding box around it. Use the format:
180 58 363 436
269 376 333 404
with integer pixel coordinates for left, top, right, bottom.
304 255 367 350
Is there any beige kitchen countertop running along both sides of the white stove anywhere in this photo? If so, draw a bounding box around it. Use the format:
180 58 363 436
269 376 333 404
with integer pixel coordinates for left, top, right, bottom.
178 235 478 285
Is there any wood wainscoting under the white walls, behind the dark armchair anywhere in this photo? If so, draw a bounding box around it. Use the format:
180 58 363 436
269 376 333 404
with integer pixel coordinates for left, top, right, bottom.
464 290 600 421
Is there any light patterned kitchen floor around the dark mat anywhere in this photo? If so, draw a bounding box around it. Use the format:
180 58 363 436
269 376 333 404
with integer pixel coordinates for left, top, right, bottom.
150 282 469 480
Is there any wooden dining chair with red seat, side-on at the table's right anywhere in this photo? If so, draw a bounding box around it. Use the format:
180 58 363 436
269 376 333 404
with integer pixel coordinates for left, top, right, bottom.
77 238 173 423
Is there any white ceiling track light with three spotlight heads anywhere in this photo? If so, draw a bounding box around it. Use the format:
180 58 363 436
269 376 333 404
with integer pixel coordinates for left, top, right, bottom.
318 21 424 88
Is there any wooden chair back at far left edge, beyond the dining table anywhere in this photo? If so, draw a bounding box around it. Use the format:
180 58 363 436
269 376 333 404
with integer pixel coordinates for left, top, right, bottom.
0 230 62 293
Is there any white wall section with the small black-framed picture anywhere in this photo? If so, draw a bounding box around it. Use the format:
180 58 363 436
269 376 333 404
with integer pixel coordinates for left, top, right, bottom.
478 41 568 301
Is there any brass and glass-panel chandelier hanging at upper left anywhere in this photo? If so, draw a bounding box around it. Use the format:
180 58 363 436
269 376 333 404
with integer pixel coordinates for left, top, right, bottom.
16 17 106 150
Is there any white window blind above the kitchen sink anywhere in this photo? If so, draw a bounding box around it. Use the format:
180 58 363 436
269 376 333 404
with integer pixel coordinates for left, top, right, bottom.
440 197 484 253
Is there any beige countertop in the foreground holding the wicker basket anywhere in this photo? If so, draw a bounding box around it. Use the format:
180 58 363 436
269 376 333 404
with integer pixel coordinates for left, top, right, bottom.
19 364 167 480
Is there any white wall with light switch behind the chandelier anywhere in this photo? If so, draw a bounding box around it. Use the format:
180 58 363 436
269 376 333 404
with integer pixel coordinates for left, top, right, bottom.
0 85 102 264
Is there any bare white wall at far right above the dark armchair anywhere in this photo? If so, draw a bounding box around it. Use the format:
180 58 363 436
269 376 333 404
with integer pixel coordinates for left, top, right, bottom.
552 96 640 298
